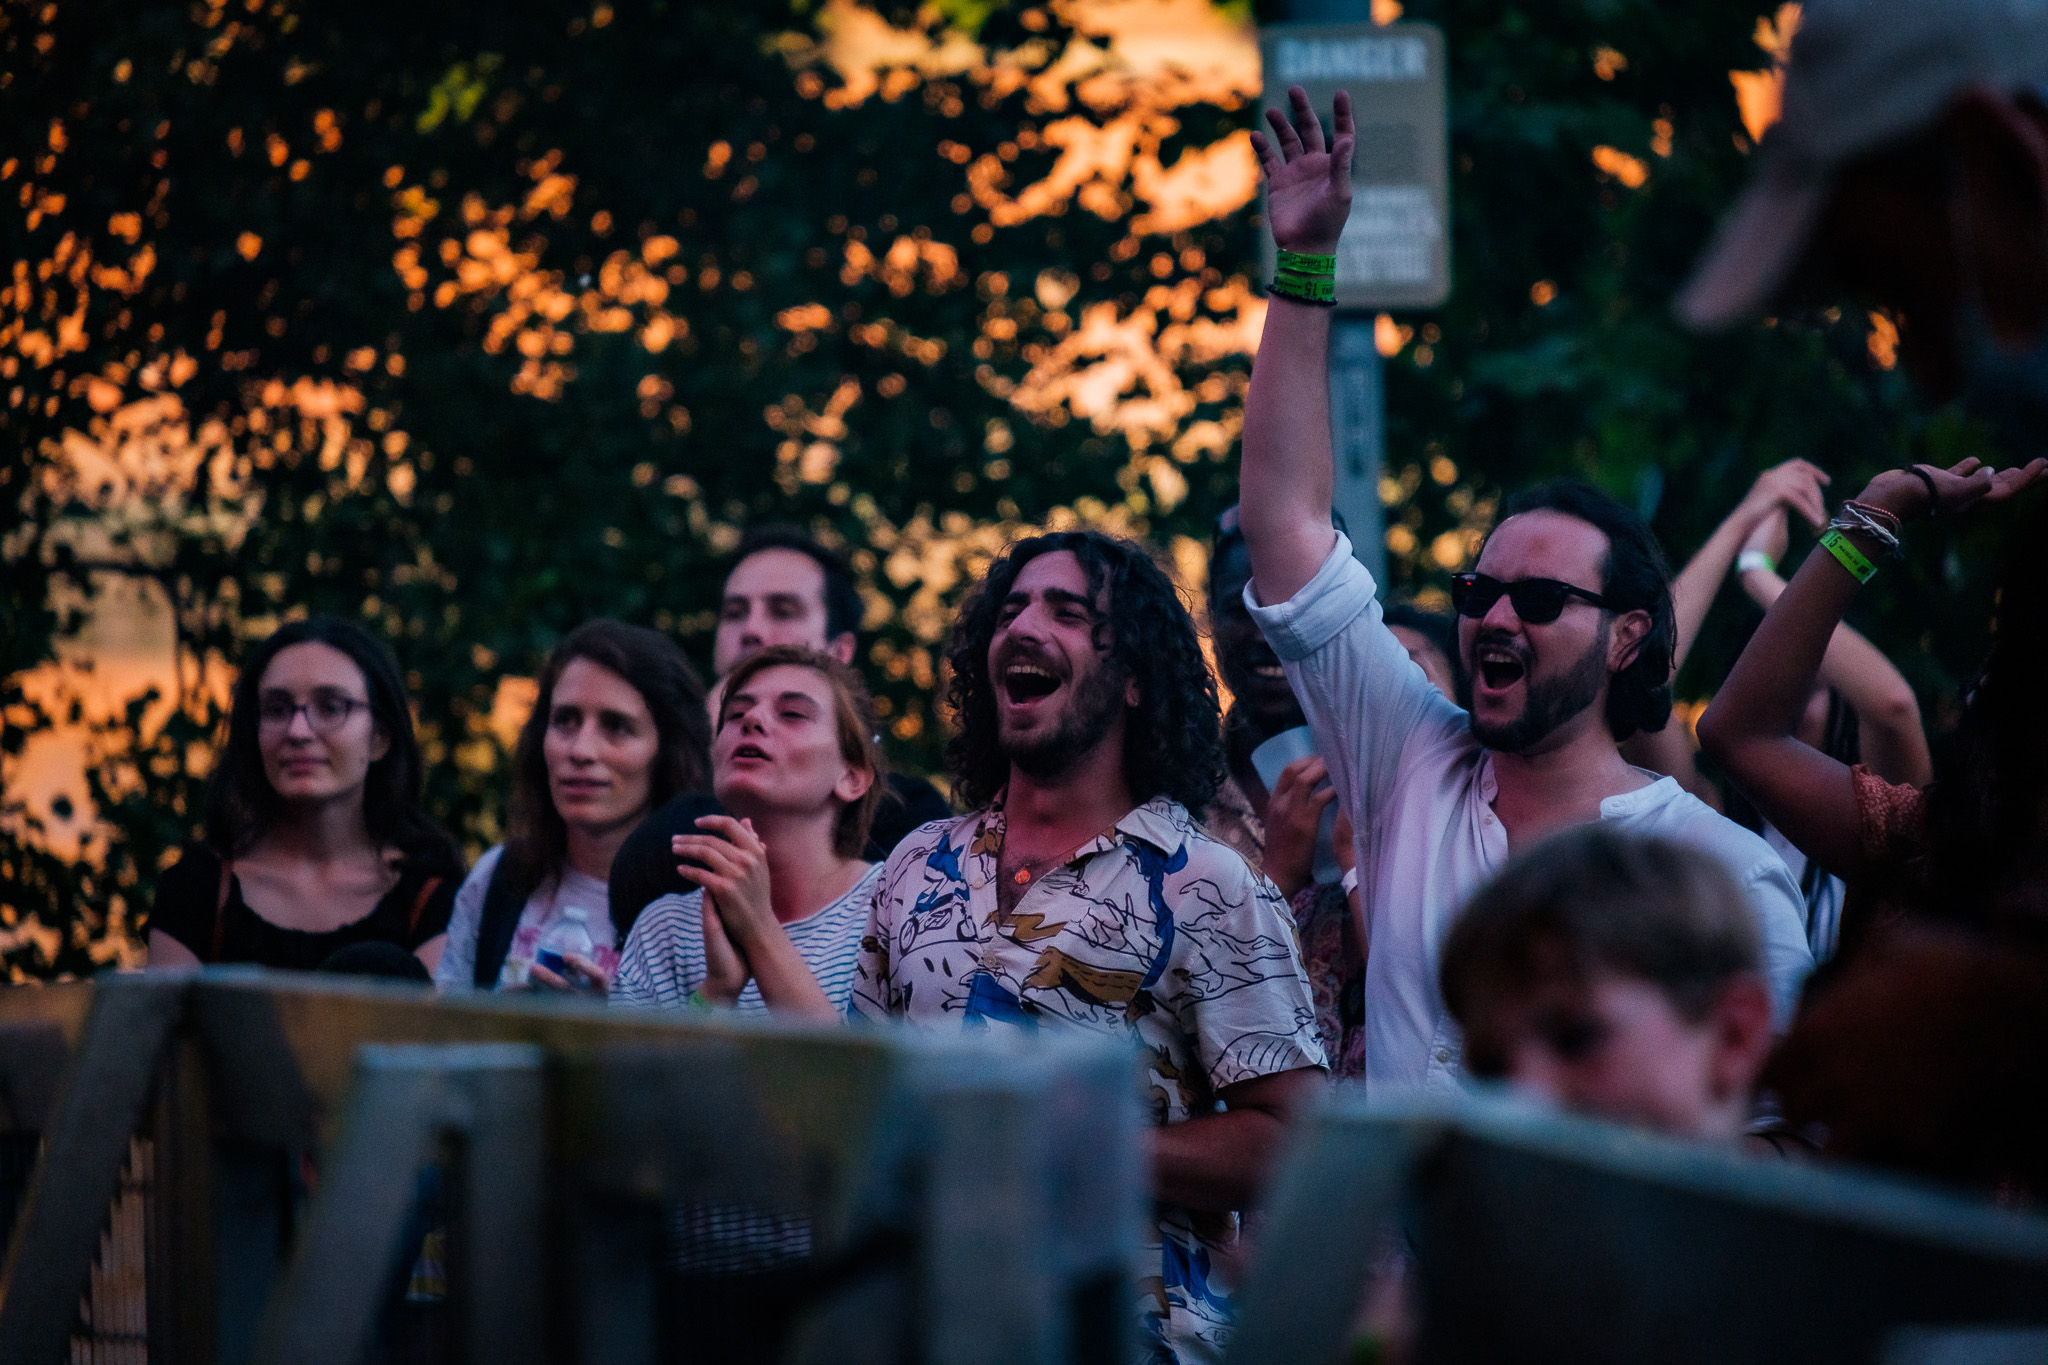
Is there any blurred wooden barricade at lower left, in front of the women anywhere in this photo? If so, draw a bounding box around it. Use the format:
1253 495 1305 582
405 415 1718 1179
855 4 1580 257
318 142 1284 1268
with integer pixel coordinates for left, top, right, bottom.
0 968 1147 1365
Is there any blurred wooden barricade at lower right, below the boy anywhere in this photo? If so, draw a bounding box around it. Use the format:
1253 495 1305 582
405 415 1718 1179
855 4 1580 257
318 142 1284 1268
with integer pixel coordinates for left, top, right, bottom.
1229 1095 2048 1365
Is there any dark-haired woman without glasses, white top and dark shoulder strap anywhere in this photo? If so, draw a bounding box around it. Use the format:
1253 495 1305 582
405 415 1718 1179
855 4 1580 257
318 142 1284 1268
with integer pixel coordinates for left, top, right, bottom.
434 620 711 990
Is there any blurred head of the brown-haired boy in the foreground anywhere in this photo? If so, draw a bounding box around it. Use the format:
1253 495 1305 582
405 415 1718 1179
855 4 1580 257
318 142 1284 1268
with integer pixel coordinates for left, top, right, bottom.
1442 823 1772 1142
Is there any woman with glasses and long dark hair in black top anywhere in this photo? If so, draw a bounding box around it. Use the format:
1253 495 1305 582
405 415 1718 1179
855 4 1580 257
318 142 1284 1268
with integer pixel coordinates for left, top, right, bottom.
150 616 463 970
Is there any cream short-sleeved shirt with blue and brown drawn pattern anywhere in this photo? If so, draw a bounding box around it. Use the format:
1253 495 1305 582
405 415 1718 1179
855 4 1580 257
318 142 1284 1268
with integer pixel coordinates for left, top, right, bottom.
852 796 1325 1365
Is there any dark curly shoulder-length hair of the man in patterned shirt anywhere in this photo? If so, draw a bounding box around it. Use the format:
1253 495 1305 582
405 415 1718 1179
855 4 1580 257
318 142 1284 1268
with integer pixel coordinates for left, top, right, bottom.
946 530 1223 812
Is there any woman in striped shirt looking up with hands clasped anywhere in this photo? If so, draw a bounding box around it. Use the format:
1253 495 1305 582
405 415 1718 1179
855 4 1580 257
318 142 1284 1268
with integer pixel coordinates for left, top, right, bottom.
610 645 887 1019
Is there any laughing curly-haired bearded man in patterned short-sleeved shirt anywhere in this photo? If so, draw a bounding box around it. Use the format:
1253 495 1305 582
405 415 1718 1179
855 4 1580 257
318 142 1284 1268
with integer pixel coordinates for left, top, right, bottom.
852 532 1325 1361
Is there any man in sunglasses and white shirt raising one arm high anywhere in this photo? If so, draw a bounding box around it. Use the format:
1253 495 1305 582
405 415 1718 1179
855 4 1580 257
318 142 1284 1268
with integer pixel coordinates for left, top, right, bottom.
1241 90 1812 1097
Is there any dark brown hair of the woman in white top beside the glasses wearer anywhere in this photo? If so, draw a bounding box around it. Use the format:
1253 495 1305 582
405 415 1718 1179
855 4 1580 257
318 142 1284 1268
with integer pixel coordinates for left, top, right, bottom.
504 620 711 892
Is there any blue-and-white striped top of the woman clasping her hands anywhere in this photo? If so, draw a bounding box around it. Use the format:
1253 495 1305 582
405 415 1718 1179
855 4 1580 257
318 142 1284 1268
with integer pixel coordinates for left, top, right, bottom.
610 864 883 1013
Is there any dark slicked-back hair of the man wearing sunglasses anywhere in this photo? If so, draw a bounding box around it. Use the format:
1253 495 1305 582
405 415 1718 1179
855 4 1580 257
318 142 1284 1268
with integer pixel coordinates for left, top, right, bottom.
1503 479 1677 741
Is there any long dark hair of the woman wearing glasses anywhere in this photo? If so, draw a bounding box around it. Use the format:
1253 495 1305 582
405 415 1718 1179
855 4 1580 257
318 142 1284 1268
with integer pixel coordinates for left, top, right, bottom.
205 616 463 874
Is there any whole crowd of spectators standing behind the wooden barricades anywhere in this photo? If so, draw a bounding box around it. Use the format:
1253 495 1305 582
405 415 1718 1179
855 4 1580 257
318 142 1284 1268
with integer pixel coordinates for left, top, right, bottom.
132 0 2048 1361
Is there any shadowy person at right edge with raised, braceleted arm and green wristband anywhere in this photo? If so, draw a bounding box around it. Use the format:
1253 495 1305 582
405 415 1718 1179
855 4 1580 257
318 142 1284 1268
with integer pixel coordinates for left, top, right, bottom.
1700 458 2048 1205
